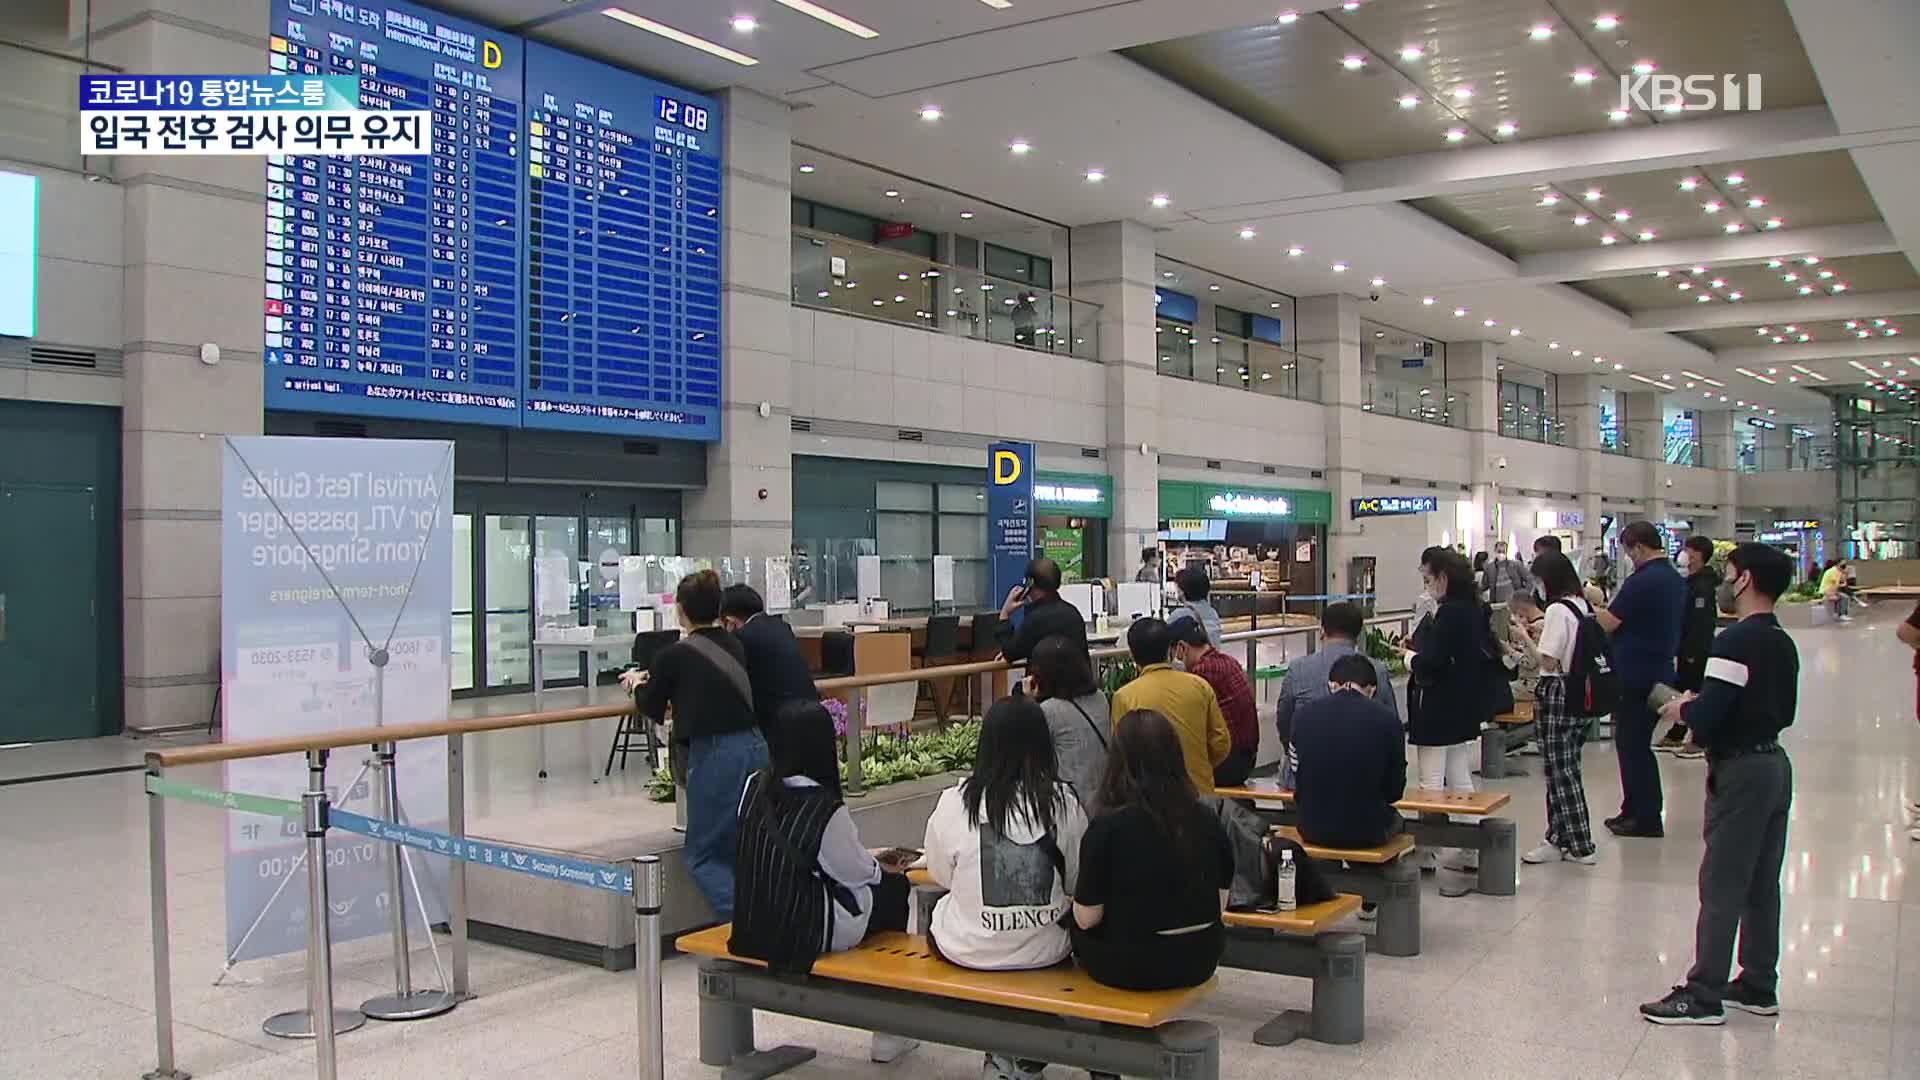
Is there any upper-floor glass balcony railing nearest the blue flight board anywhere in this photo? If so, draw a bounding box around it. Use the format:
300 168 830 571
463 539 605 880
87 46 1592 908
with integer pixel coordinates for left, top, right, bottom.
793 229 1100 359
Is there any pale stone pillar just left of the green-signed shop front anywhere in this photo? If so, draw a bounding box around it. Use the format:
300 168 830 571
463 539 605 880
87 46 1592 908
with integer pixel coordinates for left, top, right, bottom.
1068 221 1160 569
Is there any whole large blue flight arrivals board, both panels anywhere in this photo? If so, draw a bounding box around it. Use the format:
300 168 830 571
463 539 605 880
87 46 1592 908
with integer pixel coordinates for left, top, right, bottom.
265 0 722 440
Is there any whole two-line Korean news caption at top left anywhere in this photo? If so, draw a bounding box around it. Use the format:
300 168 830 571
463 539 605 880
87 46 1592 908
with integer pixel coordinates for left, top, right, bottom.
81 75 434 156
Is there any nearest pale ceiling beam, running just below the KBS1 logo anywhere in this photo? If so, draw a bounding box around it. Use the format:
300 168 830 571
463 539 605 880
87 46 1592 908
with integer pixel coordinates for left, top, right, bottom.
1194 106 1920 221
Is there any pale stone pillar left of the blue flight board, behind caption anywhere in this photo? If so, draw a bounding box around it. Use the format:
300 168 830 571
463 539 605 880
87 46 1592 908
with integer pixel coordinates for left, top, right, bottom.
90 0 267 730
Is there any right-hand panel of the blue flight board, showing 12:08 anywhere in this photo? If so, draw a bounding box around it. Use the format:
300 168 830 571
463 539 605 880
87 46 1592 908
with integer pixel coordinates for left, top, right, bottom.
522 42 720 440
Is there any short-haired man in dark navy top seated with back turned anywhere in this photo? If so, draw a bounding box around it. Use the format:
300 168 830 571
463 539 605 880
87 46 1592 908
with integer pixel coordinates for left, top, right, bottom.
1294 653 1407 847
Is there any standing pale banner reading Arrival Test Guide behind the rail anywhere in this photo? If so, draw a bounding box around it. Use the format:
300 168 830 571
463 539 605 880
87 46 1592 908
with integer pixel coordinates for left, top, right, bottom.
221 436 453 959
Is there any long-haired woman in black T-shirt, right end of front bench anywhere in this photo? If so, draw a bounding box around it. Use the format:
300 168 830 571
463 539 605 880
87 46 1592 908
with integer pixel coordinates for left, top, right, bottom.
1073 707 1233 990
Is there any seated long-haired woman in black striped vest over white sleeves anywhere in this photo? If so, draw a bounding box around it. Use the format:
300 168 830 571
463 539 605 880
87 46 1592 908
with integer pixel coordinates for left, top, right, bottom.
728 700 916 1061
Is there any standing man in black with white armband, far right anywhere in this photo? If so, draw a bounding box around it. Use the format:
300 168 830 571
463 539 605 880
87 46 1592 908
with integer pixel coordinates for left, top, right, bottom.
1640 544 1799 1024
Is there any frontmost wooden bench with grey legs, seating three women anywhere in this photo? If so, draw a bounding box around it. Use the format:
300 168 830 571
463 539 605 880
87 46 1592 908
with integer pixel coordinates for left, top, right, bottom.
676 926 1219 1080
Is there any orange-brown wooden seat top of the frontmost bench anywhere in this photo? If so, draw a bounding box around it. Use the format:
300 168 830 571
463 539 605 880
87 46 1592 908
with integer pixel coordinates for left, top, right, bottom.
676 926 1215 1028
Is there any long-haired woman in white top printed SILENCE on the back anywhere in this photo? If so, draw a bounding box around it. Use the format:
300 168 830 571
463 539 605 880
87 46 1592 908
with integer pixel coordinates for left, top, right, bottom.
925 698 1087 1080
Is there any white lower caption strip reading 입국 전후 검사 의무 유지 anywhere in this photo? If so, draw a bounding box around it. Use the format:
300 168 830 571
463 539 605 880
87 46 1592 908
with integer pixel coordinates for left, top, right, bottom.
81 110 434 156
